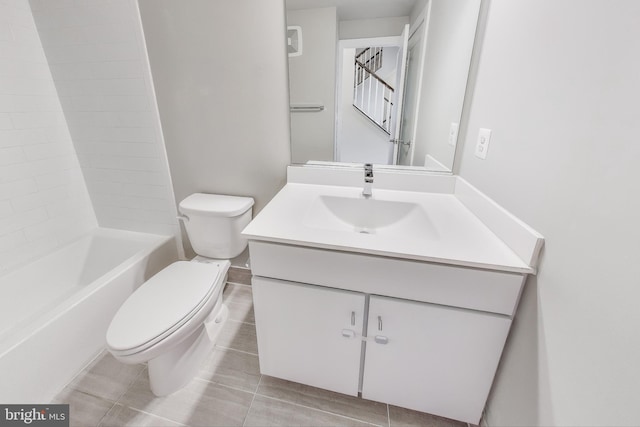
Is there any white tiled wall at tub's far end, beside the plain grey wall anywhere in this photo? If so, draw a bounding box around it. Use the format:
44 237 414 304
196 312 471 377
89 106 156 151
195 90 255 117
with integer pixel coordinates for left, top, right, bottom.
29 0 179 239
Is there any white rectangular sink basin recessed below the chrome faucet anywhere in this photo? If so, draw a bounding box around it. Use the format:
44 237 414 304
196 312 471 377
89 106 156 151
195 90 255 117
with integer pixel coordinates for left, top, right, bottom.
302 195 437 238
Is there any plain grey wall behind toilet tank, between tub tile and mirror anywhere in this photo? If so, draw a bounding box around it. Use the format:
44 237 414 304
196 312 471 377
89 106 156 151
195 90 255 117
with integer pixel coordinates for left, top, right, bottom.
140 0 290 213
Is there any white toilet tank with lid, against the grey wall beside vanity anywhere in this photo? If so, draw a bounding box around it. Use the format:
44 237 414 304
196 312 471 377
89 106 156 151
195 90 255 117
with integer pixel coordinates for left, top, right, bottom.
178 193 253 259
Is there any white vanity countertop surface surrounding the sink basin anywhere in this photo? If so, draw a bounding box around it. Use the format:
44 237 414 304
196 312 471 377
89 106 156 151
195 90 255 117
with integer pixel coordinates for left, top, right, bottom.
242 182 535 273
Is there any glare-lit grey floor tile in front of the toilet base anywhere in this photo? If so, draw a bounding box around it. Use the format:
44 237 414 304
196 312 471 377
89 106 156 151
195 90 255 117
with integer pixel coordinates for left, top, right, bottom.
118 375 253 427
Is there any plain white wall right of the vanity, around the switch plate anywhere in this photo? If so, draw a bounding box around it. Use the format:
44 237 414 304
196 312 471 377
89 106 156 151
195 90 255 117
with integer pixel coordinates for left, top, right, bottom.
459 0 640 426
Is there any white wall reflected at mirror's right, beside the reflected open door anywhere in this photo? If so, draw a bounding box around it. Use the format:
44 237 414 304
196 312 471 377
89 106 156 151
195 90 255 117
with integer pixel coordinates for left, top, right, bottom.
414 0 480 166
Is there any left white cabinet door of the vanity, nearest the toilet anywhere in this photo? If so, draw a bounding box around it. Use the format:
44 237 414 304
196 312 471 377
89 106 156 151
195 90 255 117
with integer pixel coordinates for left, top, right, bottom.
252 276 365 396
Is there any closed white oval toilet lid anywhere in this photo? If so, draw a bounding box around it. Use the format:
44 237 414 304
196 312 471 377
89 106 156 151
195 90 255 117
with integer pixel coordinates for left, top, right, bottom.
107 261 220 350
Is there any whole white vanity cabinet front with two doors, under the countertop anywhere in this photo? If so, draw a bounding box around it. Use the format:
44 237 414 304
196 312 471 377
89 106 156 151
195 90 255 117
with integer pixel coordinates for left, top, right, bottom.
250 241 525 424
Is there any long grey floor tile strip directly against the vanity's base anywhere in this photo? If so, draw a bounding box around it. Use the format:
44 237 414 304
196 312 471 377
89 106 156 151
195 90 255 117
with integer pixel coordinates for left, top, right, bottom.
257 375 389 426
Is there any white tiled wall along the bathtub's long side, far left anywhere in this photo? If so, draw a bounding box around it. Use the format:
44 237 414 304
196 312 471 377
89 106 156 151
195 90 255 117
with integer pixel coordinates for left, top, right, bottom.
0 0 96 274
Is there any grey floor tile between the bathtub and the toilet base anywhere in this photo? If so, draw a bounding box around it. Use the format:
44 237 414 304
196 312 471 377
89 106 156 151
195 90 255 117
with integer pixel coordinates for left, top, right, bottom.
69 352 145 402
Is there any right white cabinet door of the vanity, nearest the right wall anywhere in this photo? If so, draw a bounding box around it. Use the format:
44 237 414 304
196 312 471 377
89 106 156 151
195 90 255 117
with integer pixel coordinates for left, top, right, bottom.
362 296 511 424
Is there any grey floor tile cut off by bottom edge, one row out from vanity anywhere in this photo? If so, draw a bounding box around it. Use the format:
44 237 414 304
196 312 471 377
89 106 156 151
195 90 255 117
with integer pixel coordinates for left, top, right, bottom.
244 395 370 427
